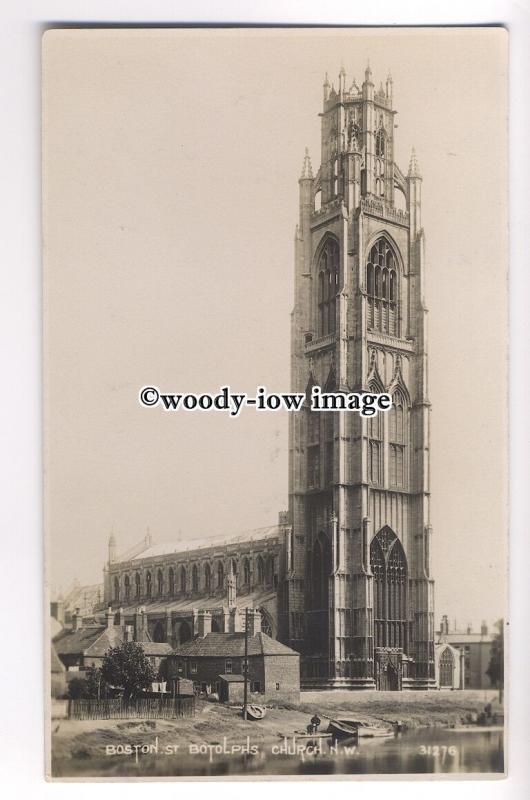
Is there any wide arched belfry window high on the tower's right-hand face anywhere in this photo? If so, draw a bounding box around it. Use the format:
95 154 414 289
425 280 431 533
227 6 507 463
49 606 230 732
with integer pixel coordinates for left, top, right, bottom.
366 236 399 336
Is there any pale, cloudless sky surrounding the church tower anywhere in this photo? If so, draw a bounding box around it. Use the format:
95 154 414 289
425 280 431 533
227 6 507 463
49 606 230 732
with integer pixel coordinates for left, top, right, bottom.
44 29 507 626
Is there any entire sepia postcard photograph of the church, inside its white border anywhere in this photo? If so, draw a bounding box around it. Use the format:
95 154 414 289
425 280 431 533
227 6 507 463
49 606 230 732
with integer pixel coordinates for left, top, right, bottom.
42 26 509 781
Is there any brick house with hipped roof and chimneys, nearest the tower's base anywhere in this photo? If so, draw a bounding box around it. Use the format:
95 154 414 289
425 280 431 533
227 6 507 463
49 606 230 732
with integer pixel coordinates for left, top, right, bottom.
168 609 300 702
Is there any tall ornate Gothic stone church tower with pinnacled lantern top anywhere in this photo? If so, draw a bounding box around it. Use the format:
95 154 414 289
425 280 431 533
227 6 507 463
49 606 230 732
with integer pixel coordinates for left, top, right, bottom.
283 67 434 689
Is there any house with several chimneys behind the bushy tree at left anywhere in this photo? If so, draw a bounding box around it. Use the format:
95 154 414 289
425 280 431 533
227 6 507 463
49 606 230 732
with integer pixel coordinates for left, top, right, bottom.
53 606 171 680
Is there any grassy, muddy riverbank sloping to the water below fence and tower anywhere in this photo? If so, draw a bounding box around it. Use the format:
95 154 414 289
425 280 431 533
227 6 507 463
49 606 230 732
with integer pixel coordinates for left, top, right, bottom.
52 691 500 777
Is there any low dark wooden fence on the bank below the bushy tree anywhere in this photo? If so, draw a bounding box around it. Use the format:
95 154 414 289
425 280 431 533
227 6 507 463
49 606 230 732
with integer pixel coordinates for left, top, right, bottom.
68 697 195 719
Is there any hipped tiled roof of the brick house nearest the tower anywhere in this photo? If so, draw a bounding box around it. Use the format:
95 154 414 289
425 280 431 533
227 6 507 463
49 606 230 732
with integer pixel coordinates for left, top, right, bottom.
173 632 298 658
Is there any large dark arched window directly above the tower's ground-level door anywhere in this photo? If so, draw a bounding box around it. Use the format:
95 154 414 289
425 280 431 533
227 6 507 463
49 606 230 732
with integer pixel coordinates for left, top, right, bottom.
370 527 408 653
